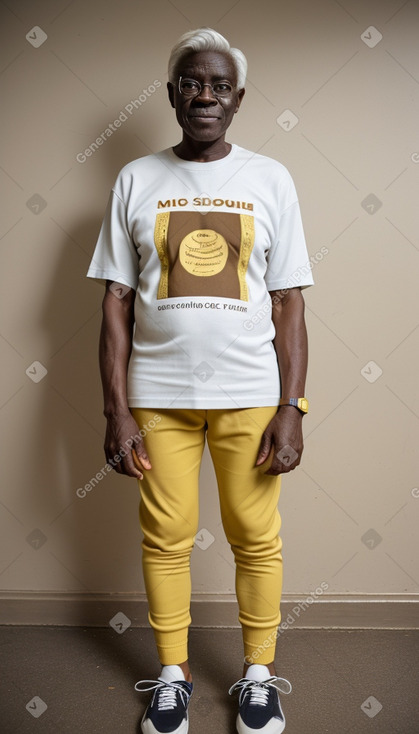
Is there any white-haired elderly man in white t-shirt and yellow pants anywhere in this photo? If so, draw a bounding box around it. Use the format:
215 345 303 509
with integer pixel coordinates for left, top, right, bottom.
88 28 313 734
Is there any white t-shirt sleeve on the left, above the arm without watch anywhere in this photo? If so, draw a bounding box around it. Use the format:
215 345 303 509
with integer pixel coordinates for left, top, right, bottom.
87 190 139 290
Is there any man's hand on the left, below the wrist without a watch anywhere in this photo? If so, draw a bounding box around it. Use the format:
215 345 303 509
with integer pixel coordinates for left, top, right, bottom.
104 413 151 479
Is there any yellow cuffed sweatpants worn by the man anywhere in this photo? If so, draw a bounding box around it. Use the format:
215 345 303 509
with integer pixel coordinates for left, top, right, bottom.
131 406 282 665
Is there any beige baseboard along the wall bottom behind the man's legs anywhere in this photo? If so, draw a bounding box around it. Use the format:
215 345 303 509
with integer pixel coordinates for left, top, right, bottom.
0 592 419 629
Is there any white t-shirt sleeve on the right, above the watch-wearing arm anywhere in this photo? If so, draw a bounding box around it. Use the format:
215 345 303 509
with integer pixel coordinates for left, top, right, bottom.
265 178 314 291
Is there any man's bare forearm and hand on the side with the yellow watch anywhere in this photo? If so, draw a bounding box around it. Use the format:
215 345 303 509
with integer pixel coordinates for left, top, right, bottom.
256 288 308 475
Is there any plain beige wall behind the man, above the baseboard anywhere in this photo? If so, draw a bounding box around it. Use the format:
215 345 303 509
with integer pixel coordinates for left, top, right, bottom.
0 0 419 608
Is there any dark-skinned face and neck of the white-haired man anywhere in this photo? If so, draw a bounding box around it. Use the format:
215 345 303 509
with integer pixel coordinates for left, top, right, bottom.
167 51 244 162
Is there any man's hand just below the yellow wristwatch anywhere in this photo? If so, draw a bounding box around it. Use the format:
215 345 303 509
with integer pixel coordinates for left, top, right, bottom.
255 405 304 476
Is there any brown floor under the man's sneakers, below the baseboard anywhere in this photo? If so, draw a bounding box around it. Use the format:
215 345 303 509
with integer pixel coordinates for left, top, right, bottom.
0 627 419 734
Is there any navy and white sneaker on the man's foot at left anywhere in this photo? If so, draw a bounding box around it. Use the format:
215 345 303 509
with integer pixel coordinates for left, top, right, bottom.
135 678 193 734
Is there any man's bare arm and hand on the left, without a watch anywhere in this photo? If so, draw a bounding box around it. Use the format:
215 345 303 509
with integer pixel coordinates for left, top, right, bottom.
99 281 151 479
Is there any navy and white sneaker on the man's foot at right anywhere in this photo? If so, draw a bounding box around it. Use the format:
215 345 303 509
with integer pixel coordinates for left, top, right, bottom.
229 666 292 734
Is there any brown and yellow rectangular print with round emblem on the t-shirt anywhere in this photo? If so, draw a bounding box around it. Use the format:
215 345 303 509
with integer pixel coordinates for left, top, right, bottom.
154 211 255 301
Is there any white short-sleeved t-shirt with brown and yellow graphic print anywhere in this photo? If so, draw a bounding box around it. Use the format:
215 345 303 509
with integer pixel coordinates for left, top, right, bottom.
87 145 313 409
